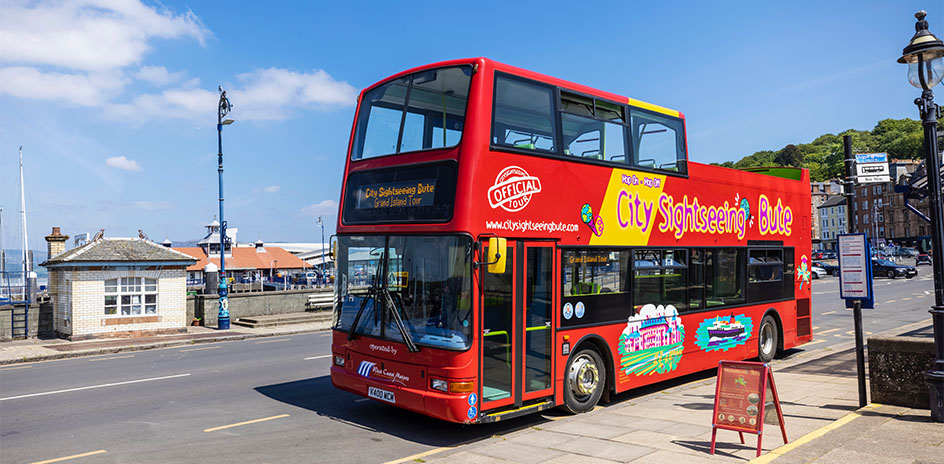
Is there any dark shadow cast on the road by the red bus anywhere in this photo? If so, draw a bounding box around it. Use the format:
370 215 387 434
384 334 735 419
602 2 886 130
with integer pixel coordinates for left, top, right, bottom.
255 376 548 447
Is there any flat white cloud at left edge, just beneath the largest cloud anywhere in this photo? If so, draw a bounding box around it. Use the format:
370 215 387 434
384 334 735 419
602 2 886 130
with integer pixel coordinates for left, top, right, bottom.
0 66 128 106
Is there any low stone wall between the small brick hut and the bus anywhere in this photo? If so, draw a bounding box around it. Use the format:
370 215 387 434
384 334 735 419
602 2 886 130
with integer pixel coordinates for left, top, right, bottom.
187 288 317 327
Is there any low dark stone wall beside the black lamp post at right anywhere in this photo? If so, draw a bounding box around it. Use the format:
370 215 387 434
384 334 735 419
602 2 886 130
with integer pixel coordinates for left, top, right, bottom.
868 337 934 409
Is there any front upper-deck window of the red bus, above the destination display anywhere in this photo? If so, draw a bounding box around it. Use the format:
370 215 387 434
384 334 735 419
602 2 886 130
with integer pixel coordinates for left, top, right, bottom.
351 66 472 160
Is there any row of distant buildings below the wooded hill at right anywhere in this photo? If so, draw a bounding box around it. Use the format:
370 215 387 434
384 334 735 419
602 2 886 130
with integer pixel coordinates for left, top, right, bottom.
810 160 931 250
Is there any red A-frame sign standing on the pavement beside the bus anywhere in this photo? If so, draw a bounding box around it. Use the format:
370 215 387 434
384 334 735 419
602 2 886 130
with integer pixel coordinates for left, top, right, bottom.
711 361 787 456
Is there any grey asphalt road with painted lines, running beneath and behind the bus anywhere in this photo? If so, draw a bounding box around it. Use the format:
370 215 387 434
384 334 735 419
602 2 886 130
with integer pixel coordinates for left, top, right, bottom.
0 276 933 463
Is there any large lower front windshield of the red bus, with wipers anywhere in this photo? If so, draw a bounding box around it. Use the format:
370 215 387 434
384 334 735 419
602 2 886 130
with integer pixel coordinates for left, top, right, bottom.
334 235 472 350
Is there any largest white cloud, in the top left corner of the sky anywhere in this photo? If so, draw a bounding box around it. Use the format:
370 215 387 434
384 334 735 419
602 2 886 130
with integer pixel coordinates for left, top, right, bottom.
0 0 211 71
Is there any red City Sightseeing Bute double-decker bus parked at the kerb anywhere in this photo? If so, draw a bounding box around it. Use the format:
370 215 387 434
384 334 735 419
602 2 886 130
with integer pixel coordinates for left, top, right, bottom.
331 58 812 423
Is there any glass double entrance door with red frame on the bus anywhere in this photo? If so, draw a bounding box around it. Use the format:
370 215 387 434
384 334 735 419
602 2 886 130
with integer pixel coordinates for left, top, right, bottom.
481 240 557 411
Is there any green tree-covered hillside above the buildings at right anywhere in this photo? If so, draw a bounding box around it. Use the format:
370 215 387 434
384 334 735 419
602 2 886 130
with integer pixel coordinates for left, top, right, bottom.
712 118 944 181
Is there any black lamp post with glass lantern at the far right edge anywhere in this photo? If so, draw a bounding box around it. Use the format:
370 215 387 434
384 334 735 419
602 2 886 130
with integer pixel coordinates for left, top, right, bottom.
898 10 944 422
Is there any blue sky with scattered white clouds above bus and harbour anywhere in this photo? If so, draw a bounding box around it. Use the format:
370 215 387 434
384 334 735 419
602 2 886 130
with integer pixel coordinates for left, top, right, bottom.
0 0 944 249
